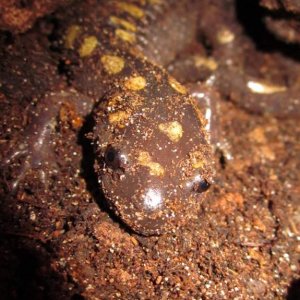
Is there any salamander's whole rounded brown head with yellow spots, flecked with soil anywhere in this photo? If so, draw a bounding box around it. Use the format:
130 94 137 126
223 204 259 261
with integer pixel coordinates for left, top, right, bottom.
94 81 212 235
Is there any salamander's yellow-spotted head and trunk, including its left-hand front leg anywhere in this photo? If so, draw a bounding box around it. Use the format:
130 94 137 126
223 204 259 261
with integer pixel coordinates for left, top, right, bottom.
1 0 213 235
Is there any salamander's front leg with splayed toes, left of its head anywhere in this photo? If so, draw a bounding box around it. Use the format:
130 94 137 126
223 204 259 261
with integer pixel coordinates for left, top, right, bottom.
1 90 94 194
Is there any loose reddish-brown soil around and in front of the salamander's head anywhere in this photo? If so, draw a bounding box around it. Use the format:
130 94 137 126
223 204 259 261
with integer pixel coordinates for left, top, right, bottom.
0 0 300 300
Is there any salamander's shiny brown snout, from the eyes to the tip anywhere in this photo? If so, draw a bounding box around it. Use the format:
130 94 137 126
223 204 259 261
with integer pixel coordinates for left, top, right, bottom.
96 144 210 235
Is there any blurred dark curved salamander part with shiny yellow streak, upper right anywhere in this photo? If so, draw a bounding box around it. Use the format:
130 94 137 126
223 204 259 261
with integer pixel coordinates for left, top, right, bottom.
199 0 300 117
